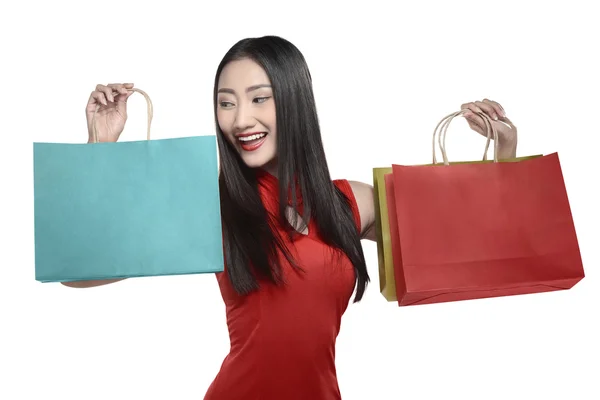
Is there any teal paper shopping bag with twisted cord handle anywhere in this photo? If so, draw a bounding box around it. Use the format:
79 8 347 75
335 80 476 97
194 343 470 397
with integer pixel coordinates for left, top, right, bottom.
33 89 224 282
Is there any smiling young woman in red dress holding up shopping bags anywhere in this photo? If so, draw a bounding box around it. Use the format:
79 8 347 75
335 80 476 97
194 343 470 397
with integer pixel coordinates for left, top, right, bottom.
66 36 516 400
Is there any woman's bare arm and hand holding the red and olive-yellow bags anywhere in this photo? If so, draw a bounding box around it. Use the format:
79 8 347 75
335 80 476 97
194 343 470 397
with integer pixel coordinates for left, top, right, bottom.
349 99 517 241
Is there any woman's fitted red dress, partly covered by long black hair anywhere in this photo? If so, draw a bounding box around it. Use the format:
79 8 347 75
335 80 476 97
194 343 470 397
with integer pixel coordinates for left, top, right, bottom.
204 173 360 400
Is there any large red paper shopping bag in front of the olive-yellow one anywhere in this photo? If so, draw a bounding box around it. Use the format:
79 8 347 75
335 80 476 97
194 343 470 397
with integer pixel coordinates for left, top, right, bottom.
386 112 584 306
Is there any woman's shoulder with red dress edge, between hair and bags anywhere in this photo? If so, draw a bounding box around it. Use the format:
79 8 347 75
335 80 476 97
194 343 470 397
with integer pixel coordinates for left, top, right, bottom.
334 179 375 239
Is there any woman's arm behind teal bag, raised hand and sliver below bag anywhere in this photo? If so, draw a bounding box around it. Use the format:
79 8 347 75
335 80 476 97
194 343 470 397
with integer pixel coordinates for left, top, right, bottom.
61 83 134 288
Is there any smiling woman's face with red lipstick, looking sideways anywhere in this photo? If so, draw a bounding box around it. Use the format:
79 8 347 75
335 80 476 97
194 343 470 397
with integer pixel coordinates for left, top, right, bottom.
217 59 277 170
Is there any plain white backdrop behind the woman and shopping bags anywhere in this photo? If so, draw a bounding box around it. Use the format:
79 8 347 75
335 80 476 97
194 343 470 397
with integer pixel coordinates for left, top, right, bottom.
0 0 600 400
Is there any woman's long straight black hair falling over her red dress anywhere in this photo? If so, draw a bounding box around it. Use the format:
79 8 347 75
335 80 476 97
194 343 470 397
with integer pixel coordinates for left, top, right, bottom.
214 36 369 302
